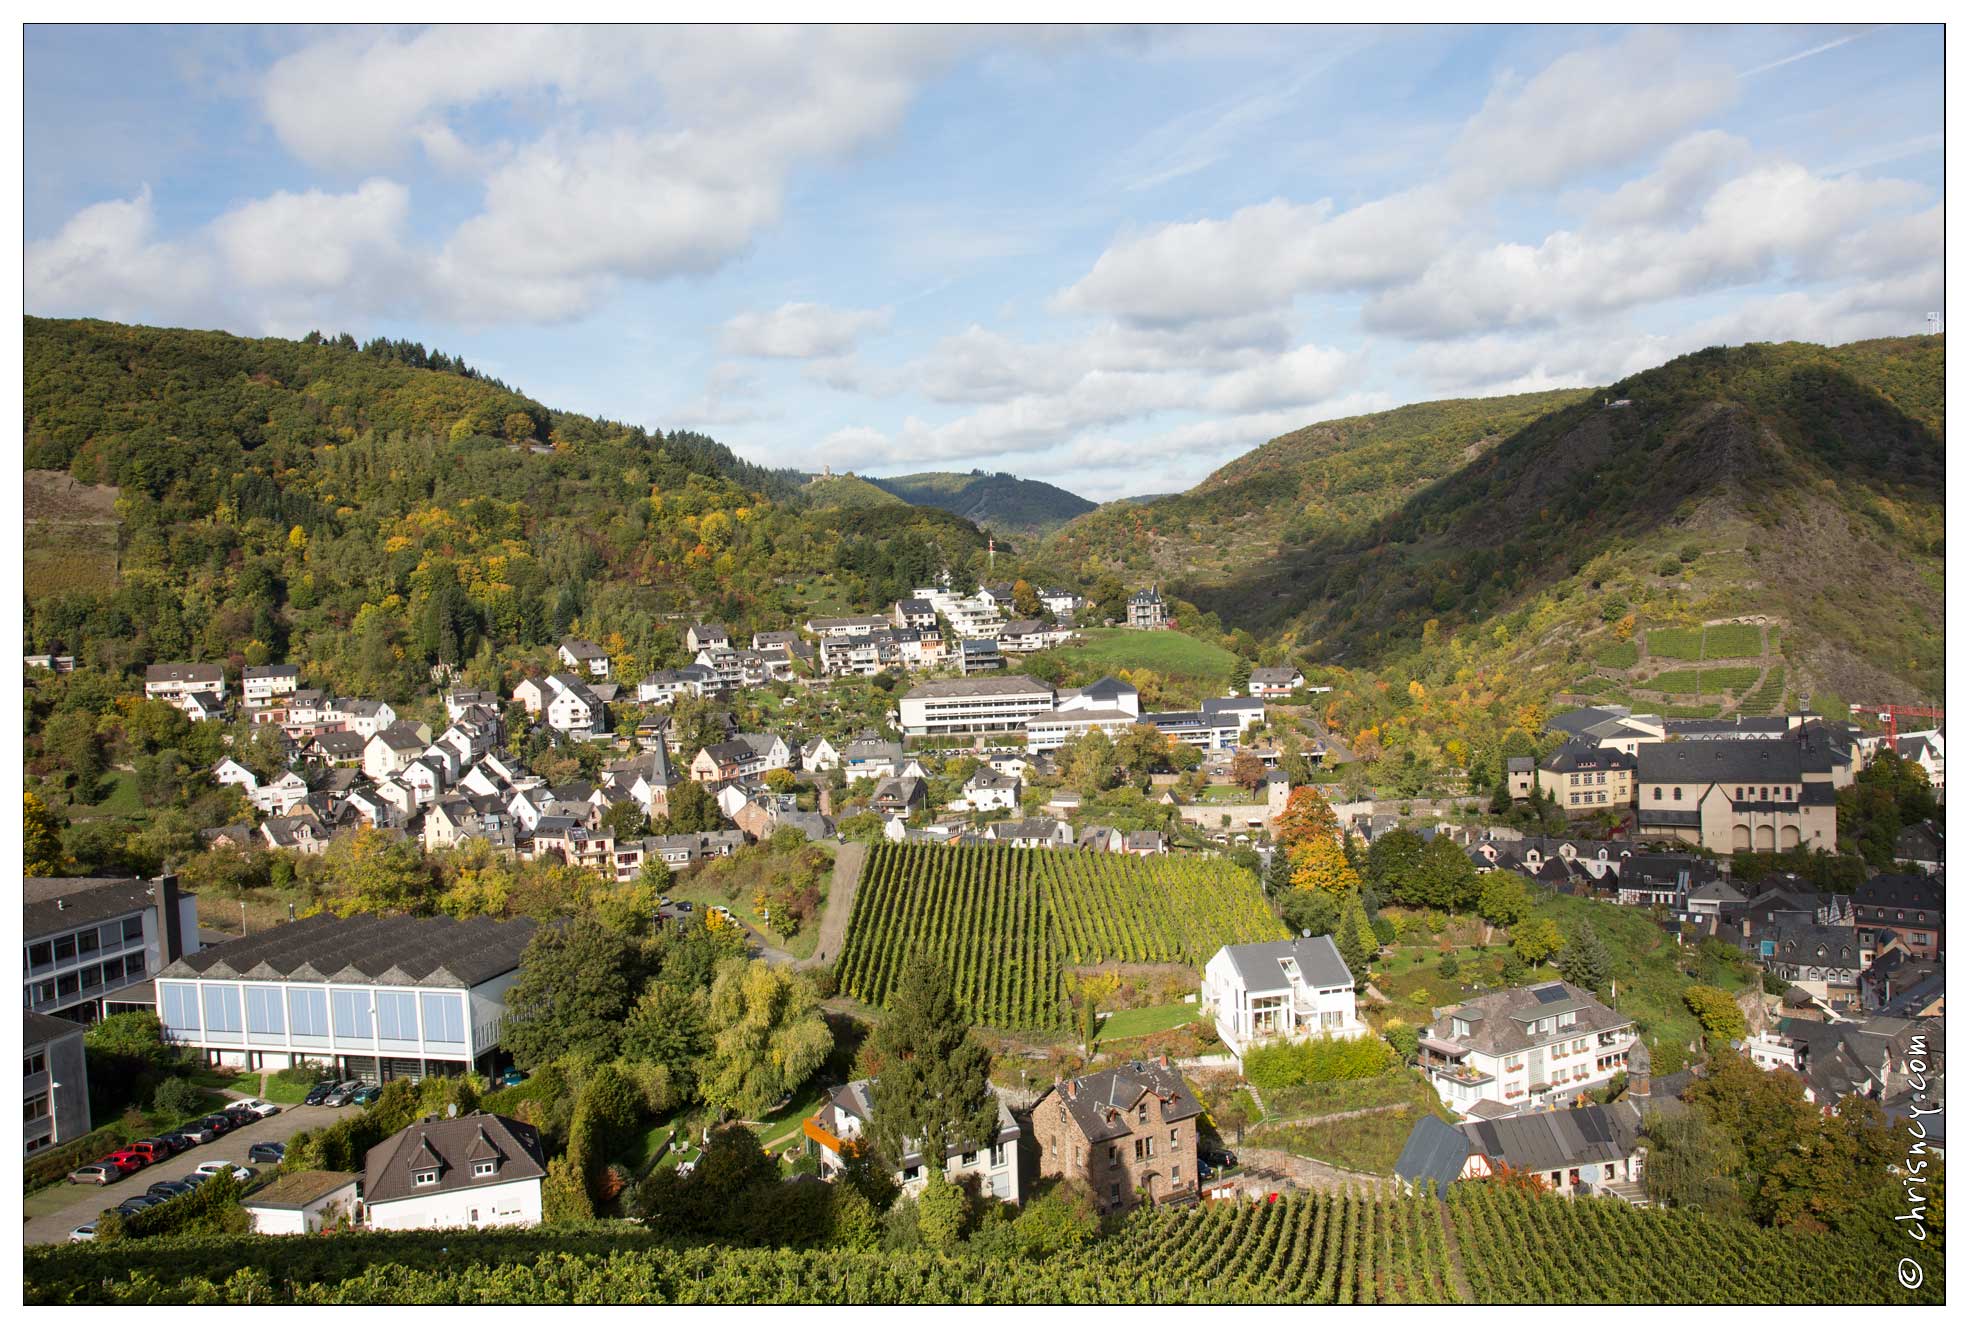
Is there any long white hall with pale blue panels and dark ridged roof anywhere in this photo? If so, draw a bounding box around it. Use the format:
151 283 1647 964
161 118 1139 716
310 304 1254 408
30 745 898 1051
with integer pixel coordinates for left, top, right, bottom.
158 914 534 1081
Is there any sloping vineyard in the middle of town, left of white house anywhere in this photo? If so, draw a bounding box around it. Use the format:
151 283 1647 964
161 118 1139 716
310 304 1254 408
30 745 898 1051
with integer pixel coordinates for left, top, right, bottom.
839 843 1286 1030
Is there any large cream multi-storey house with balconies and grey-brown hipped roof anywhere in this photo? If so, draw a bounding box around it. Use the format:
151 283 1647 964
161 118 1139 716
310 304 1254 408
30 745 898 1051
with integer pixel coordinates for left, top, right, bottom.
1420 982 1634 1118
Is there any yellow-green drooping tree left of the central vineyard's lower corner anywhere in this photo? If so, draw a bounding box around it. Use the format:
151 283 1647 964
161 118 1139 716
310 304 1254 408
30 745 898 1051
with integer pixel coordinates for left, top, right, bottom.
701 959 835 1118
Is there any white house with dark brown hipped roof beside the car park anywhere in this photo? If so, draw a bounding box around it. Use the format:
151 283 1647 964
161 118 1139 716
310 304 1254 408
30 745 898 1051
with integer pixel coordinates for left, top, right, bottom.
362 1112 547 1231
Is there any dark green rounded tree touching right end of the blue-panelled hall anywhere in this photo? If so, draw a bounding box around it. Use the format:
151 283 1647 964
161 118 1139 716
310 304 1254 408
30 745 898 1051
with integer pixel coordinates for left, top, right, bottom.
500 918 646 1071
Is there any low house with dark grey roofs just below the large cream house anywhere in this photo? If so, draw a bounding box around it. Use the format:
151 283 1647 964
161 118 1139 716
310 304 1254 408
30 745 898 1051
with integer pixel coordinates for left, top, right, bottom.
1394 1099 1646 1201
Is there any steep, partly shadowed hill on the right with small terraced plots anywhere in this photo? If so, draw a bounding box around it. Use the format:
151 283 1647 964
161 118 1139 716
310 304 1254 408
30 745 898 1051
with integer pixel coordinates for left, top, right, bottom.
1205 337 1943 701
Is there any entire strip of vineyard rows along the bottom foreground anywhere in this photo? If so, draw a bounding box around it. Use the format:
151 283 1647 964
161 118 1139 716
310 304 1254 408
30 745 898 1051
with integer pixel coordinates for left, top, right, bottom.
24 1183 1943 1305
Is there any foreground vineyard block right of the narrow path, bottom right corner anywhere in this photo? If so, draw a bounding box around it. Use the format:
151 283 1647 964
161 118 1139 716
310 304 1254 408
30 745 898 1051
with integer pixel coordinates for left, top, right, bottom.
1449 1185 1941 1305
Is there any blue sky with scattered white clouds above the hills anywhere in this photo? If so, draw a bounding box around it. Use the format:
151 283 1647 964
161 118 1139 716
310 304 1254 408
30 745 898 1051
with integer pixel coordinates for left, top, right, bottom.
24 26 1943 500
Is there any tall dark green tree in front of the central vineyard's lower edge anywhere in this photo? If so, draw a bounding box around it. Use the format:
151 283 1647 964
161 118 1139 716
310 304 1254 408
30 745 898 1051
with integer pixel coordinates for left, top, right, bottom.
868 951 1000 1171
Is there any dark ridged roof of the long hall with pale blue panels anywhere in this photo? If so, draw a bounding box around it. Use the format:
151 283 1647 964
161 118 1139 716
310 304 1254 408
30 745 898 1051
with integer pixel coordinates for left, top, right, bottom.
158 914 536 988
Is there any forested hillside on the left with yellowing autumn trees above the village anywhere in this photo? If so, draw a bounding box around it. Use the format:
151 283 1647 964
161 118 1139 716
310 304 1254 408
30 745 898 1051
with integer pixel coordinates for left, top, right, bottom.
24 319 985 697
